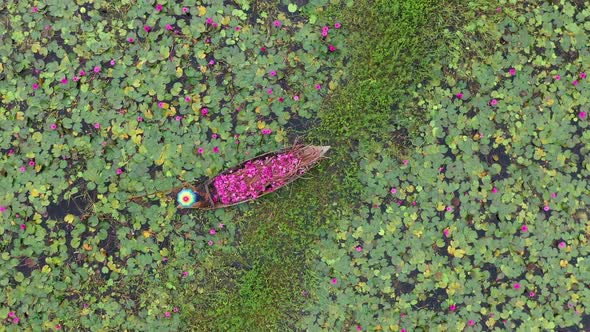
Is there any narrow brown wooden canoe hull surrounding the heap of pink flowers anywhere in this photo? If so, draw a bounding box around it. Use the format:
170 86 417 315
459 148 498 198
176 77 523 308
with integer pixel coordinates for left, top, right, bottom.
171 145 330 210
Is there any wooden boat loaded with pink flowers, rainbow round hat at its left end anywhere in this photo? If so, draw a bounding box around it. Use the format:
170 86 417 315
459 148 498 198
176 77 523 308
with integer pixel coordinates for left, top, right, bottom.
171 144 330 210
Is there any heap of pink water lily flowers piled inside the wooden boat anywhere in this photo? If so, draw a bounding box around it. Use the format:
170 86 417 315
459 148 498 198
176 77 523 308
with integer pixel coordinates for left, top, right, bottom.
213 153 301 204
